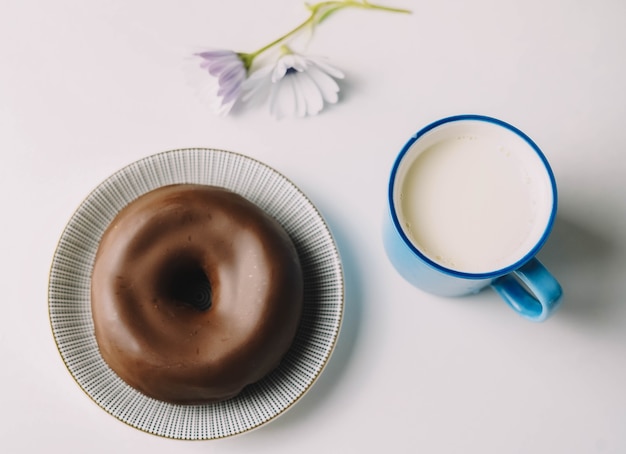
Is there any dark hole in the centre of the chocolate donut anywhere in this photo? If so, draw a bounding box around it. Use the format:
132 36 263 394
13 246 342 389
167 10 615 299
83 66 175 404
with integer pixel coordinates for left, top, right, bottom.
161 259 212 311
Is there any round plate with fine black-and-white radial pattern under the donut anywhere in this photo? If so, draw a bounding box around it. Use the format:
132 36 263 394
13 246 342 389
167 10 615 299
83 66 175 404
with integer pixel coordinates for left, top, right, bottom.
48 149 344 440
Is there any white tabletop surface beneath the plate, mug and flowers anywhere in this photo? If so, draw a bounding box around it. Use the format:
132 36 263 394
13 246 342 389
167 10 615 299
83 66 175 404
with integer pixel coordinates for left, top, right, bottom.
0 0 626 454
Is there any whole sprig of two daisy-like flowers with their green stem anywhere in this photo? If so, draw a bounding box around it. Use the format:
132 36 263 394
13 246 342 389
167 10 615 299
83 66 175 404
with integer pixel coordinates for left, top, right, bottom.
190 0 410 118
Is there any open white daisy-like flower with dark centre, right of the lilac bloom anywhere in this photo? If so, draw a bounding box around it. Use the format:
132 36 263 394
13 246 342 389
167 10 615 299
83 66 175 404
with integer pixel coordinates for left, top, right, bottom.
242 52 344 118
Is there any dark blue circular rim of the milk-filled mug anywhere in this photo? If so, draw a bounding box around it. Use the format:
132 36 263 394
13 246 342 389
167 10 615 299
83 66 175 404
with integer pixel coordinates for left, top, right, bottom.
387 114 558 280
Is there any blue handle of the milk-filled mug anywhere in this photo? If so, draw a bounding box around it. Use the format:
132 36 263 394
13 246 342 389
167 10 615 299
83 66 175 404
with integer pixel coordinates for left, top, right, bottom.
491 257 563 322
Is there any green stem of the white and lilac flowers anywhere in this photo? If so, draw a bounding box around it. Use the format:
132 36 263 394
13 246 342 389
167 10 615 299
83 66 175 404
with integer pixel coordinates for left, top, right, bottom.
239 0 411 70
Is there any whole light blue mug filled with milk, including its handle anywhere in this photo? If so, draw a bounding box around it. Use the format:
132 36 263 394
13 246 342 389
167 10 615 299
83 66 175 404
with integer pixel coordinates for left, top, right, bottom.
383 115 563 321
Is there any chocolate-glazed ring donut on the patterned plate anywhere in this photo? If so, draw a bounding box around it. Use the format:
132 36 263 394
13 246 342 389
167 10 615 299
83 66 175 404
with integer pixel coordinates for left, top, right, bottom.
91 184 303 404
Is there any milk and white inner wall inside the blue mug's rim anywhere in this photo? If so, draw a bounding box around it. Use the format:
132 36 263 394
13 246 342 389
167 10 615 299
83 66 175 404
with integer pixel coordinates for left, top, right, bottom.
394 121 553 273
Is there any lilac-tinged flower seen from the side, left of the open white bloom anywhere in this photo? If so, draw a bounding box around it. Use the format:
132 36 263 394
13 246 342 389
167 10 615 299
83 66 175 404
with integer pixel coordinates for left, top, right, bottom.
196 50 247 115
